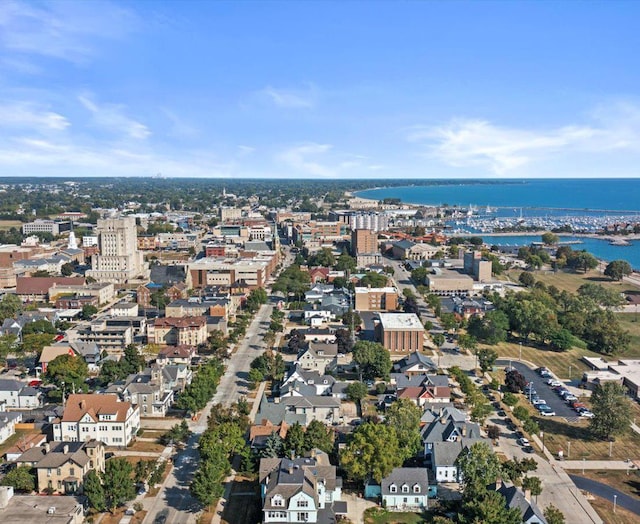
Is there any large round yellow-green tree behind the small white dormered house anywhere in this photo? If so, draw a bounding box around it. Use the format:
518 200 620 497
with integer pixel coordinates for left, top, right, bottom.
340 422 402 482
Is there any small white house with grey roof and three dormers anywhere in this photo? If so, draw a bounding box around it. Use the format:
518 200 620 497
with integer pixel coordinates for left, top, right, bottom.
380 468 429 511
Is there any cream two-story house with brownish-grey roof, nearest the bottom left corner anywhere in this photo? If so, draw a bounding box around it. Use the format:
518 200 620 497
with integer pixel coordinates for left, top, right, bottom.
16 440 105 495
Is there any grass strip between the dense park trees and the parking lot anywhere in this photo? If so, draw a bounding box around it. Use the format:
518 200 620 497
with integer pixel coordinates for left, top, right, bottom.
488 342 602 380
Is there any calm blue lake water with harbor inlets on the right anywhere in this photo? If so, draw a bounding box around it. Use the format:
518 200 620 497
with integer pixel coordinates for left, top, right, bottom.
357 179 640 269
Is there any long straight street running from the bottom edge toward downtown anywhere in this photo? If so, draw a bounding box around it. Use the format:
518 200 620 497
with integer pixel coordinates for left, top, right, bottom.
143 304 273 524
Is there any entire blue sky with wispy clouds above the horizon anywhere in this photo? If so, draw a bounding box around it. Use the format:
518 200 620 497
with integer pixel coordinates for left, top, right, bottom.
0 0 640 179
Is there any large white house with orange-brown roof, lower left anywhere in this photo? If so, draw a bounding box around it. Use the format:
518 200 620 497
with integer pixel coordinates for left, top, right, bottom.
53 394 140 446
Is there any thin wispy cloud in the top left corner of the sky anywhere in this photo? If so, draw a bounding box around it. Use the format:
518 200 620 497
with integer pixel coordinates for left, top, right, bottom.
0 0 137 63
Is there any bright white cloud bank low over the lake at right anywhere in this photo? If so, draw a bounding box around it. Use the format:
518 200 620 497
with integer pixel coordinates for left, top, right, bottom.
406 103 640 174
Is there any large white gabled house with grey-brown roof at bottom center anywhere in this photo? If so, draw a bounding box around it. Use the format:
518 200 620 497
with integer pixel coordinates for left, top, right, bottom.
259 452 347 524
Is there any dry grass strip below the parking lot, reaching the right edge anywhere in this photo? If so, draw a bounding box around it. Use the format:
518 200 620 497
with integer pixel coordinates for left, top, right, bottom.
533 417 640 460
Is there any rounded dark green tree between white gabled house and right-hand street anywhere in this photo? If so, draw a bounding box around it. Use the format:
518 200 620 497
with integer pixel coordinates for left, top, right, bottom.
456 442 500 501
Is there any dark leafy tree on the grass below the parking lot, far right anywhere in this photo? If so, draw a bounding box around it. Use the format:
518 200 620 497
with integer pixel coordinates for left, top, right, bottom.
590 382 631 440
